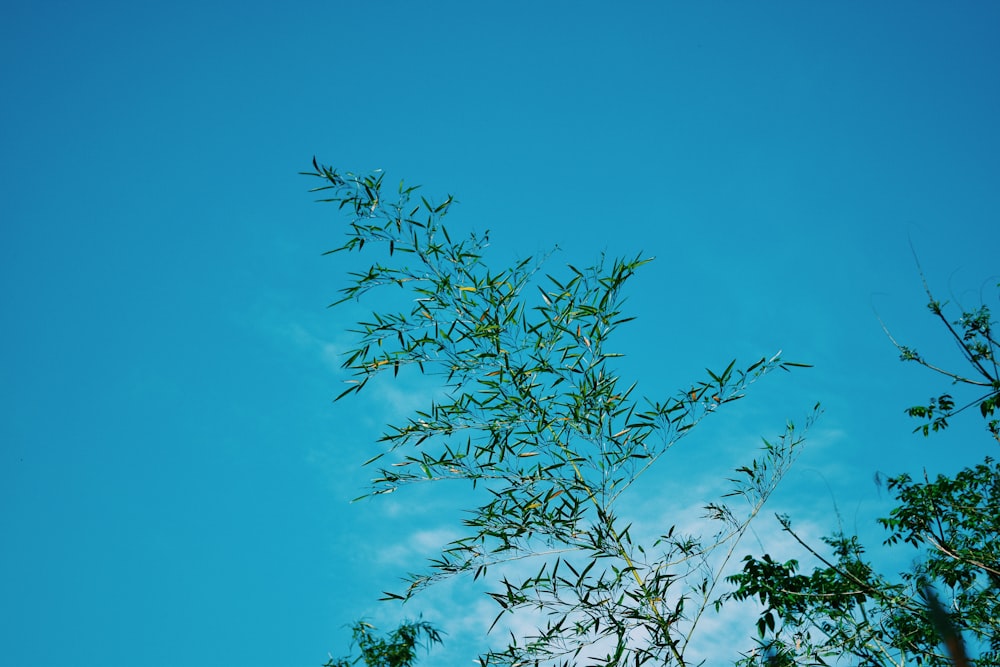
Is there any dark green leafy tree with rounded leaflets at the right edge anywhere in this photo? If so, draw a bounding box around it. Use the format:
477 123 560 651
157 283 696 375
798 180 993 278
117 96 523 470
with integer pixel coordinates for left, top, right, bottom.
730 274 1000 665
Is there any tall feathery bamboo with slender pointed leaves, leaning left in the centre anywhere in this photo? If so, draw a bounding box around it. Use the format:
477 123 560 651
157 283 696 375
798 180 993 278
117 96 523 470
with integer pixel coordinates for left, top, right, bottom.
308 160 815 666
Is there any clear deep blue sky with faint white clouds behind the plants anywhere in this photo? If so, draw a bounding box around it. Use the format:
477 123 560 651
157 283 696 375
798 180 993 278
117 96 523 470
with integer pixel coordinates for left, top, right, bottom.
0 0 1000 667
